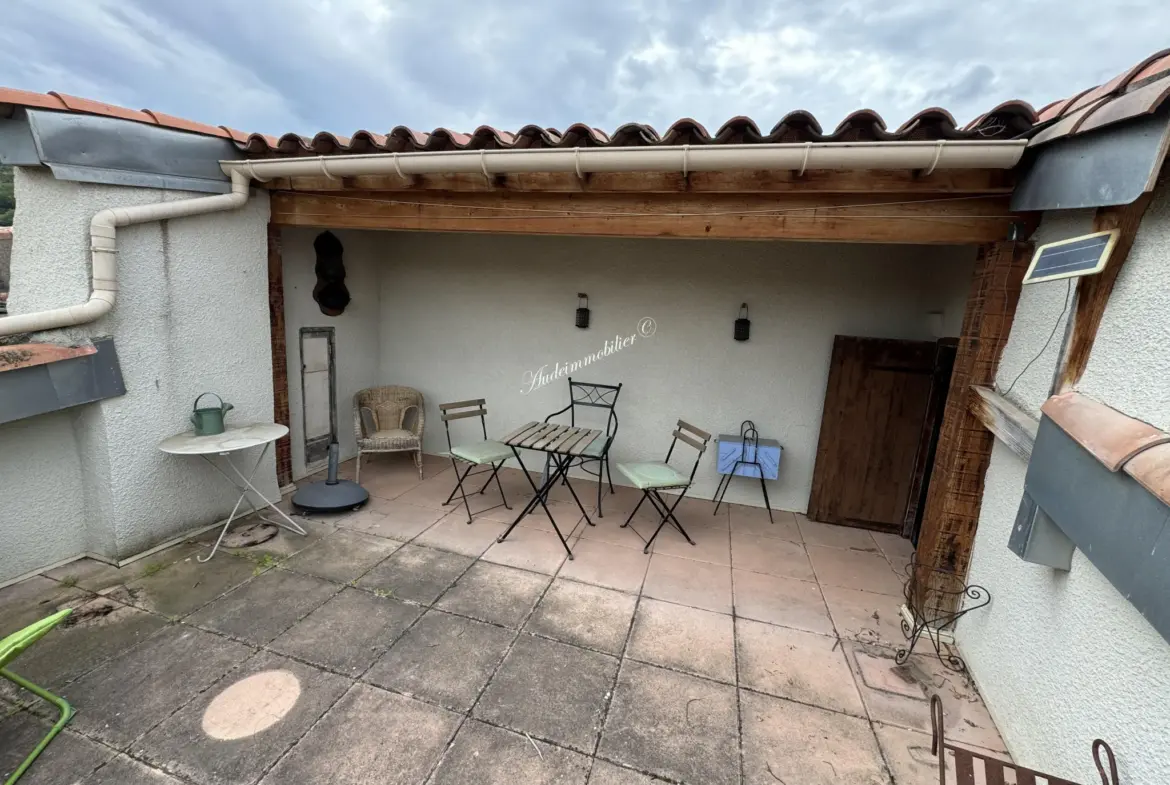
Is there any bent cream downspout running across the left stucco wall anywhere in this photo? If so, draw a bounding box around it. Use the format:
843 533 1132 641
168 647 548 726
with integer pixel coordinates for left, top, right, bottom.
0 172 249 337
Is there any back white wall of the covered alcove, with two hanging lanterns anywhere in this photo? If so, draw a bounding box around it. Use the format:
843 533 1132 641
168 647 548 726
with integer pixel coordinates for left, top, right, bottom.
334 233 973 510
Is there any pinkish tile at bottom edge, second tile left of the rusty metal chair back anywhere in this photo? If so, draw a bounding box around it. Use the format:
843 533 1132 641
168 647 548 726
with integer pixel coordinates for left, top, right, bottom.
739 690 889 785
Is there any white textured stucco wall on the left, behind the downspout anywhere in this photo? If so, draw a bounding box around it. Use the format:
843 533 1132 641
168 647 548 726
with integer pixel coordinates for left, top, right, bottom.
0 168 276 580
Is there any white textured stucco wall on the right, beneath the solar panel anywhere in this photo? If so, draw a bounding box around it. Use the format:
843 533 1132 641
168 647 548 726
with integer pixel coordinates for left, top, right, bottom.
957 179 1170 783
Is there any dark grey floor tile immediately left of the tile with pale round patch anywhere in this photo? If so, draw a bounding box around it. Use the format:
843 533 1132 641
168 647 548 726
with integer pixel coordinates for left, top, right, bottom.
61 627 253 746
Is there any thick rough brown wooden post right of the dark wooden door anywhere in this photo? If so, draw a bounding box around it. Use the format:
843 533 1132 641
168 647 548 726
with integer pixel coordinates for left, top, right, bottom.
916 242 1032 591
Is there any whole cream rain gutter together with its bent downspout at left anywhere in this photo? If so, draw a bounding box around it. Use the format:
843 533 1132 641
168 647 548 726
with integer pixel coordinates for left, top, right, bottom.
0 139 1027 337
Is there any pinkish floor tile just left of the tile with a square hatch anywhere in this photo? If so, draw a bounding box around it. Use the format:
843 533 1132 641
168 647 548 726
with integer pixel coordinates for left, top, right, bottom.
736 619 866 717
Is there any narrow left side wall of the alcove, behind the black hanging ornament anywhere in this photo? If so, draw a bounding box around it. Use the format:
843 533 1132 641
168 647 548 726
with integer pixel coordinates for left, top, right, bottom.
282 228 381 480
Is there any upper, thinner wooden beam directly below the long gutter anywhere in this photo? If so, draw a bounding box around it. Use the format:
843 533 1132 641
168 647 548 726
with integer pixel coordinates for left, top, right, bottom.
264 170 1016 194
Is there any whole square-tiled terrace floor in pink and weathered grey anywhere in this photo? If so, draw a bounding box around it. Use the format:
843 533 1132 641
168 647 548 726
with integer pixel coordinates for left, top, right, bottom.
0 459 1003 785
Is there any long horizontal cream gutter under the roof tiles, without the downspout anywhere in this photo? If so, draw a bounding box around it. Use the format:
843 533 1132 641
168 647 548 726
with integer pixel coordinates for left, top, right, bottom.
220 139 1027 181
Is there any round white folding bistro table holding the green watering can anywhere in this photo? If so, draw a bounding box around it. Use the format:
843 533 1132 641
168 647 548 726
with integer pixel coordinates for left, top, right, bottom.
158 422 305 562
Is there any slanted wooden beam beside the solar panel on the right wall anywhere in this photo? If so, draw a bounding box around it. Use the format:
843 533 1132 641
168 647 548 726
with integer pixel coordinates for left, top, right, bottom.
1052 193 1152 393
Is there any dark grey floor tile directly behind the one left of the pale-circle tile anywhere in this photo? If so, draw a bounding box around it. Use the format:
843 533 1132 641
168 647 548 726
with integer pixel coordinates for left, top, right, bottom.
188 570 340 646
